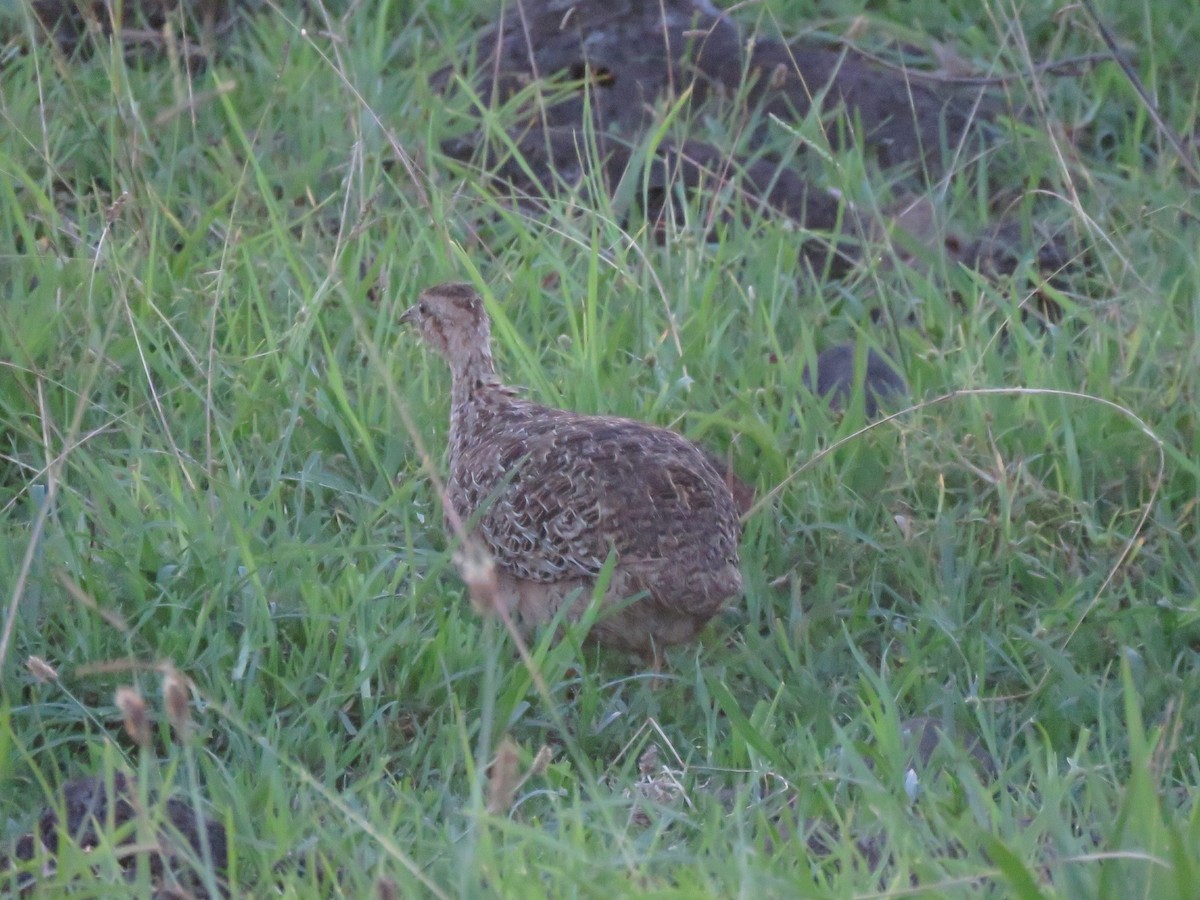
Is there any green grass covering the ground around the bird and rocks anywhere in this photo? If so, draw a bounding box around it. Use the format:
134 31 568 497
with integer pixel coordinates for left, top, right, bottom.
0 0 1200 898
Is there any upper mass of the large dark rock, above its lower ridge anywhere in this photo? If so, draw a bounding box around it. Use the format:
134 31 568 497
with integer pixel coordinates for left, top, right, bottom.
446 0 1001 178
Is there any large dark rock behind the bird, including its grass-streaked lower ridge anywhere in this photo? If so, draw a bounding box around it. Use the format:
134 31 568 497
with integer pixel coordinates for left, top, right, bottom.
433 0 1000 275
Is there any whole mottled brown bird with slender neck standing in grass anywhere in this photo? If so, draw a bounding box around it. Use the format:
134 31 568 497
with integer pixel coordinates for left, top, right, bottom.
402 283 742 661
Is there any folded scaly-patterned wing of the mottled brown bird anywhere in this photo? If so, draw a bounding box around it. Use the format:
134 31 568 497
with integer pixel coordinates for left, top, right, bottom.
458 408 738 581
